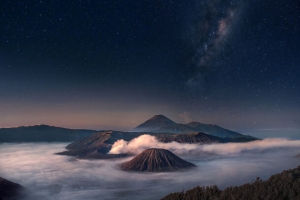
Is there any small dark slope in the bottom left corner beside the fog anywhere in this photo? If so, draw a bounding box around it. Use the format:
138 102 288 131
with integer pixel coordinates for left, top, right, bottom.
0 177 25 200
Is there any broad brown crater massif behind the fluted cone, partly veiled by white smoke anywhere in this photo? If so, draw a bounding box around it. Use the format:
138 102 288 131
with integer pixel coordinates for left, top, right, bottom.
57 131 223 159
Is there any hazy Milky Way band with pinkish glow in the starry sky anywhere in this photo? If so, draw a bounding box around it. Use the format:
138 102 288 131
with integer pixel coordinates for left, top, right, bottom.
187 0 242 89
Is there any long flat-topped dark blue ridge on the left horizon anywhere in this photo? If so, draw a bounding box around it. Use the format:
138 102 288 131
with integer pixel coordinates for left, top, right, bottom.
0 125 96 143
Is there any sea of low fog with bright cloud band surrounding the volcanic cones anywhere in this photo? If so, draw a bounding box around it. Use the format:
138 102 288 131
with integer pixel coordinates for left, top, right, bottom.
0 139 300 200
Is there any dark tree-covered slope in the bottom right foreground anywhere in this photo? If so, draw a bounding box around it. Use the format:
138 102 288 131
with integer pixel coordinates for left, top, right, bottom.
162 166 300 200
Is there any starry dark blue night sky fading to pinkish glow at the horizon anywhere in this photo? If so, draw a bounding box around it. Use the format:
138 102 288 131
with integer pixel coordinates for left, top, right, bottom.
0 0 300 130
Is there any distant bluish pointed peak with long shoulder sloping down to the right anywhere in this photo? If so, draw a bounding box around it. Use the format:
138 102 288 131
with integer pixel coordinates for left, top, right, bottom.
132 115 255 141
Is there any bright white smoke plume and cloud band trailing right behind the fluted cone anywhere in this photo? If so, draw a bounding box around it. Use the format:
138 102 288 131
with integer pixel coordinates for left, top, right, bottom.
109 135 300 156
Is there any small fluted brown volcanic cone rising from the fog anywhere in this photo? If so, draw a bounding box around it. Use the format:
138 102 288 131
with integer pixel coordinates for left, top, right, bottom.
120 148 195 172
